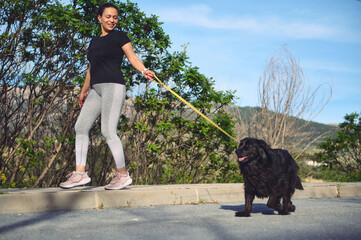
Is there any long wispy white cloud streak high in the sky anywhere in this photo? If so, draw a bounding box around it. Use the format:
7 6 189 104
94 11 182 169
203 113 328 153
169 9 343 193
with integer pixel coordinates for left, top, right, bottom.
158 4 344 39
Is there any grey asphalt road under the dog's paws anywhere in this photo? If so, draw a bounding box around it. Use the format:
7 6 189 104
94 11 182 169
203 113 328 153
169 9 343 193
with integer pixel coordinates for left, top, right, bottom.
0 198 361 240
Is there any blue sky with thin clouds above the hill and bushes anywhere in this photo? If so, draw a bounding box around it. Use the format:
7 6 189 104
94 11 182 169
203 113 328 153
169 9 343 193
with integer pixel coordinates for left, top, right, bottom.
132 0 361 124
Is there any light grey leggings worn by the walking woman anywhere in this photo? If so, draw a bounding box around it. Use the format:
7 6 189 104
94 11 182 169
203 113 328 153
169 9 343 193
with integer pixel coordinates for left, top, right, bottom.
75 83 126 168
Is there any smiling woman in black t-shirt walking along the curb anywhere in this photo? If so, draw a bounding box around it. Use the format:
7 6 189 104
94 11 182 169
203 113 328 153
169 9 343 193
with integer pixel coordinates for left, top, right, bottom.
60 3 154 189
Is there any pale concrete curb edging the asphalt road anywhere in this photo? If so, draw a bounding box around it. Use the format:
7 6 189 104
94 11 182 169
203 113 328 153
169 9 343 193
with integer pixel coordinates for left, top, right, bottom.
0 183 361 214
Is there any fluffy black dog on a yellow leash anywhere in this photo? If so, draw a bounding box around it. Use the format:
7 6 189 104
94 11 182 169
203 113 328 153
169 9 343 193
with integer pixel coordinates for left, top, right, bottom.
236 138 303 217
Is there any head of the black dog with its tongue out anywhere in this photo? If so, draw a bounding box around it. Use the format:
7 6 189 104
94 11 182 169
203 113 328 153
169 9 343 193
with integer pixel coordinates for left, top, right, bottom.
236 138 271 164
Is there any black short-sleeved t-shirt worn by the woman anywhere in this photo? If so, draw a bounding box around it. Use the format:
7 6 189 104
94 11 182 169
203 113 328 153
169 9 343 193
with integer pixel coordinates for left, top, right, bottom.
87 30 130 86
